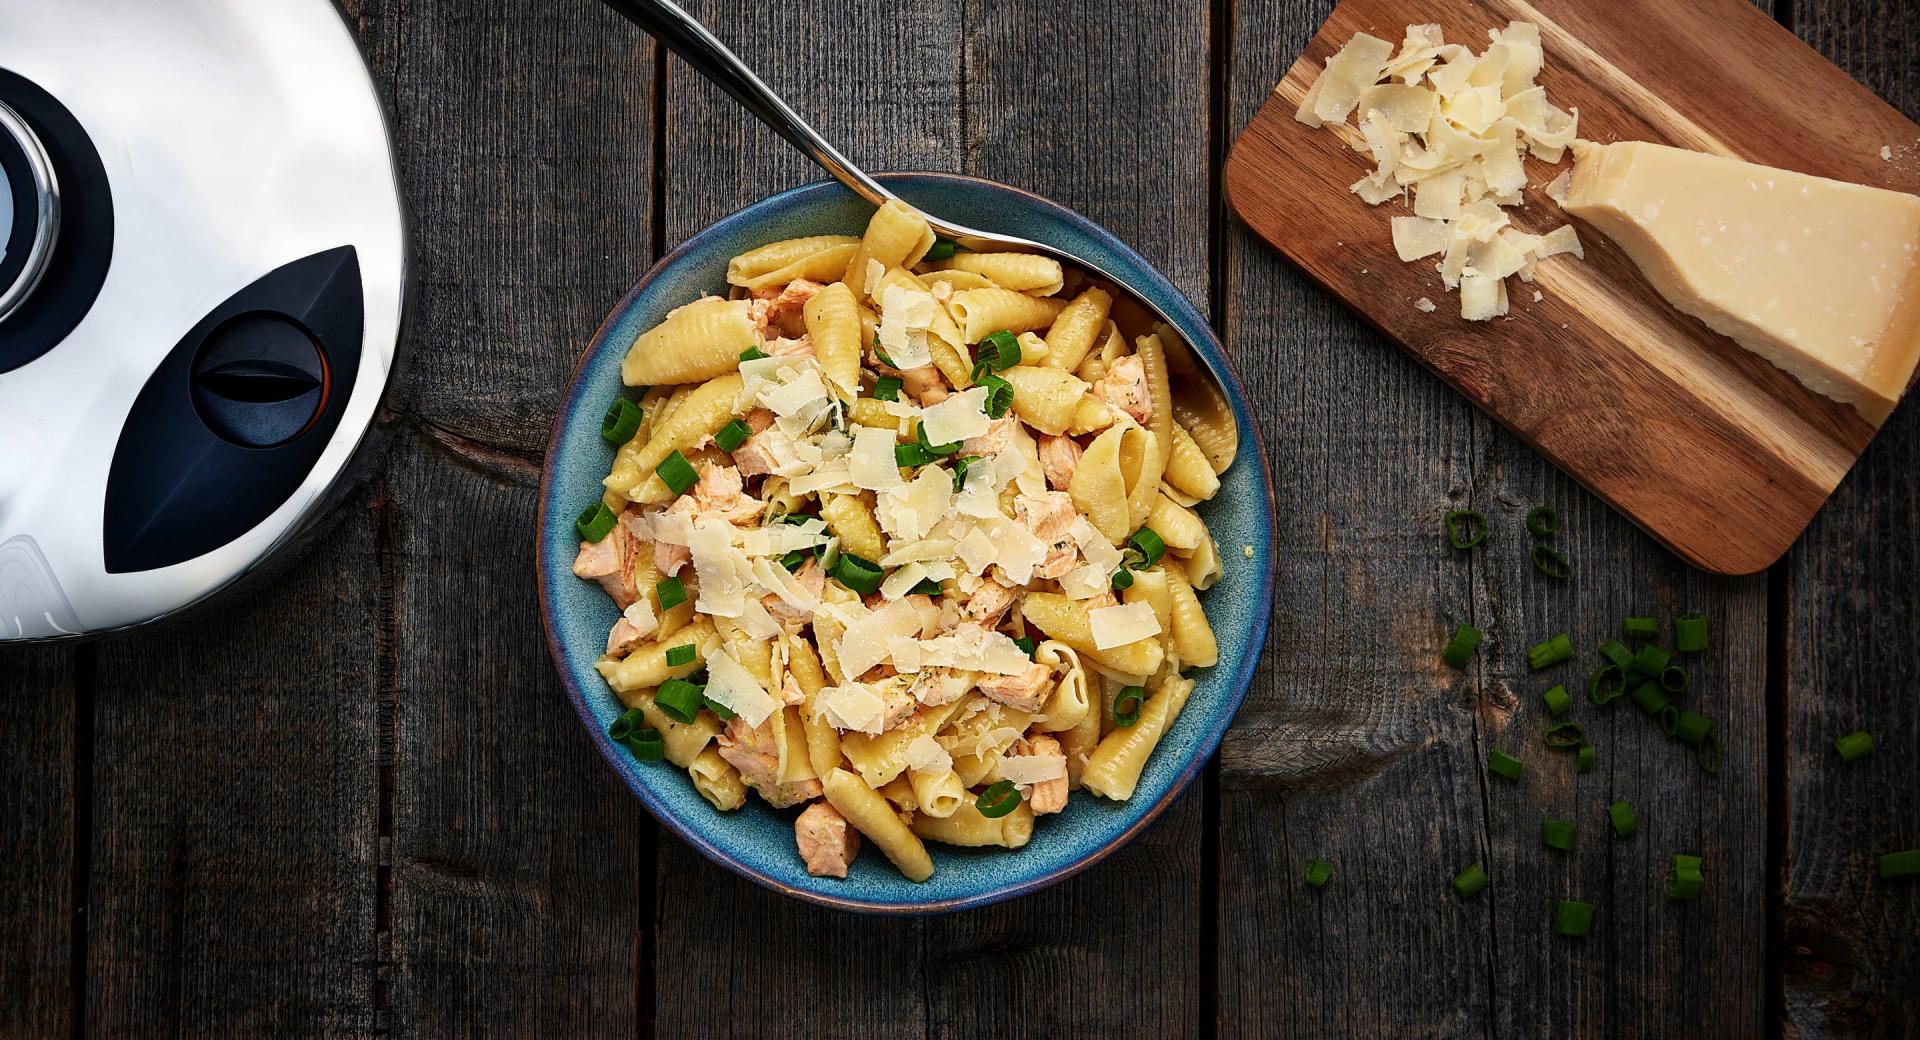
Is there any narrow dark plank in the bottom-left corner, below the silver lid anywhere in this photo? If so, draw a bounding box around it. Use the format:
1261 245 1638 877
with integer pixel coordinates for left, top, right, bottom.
0 647 84 1036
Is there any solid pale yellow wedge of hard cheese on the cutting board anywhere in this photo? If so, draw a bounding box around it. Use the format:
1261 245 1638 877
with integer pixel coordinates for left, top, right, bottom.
1567 140 1920 424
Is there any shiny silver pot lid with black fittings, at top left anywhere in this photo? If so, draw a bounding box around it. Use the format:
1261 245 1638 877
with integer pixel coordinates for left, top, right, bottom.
0 0 407 643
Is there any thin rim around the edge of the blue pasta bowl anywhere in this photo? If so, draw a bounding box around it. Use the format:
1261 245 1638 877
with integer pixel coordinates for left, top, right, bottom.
534 171 1277 917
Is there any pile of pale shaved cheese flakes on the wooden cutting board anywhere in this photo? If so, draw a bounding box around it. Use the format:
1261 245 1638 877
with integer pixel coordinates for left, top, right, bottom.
1294 21 1582 320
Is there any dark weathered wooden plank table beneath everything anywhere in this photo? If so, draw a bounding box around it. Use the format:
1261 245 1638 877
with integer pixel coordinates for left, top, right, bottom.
0 0 1920 1038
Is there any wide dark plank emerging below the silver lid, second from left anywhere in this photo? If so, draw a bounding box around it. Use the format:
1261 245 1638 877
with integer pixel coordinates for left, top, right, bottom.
86 495 378 1036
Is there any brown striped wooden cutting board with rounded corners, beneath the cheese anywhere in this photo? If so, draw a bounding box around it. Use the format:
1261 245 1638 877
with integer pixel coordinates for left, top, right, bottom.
1225 0 1920 574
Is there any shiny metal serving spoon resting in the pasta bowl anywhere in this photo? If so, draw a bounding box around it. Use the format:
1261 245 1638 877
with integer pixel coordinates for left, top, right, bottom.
605 0 1240 470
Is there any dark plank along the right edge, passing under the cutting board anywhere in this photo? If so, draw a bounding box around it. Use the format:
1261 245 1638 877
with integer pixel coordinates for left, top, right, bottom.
1772 0 1920 1036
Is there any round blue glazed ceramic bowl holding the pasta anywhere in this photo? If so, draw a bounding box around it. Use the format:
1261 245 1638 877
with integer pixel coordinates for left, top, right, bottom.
538 173 1273 913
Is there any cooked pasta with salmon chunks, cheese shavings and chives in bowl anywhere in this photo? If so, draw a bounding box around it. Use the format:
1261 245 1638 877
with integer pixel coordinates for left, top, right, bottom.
574 201 1231 881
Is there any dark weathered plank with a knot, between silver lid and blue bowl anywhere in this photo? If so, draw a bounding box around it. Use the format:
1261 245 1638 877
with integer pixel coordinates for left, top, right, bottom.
359 0 655 1036
